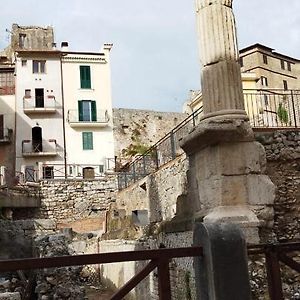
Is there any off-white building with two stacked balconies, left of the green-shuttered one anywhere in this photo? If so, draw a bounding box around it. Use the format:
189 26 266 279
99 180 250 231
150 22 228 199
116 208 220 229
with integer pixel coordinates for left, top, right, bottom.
15 50 65 181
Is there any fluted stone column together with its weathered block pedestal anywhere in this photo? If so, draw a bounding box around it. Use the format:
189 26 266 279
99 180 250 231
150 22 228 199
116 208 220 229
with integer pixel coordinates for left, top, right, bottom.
181 0 275 243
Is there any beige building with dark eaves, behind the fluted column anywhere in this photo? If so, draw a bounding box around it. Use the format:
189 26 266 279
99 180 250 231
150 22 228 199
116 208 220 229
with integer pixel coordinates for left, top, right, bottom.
184 44 300 127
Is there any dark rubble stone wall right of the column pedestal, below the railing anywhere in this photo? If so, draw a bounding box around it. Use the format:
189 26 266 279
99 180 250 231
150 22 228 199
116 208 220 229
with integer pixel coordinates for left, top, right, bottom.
256 131 300 242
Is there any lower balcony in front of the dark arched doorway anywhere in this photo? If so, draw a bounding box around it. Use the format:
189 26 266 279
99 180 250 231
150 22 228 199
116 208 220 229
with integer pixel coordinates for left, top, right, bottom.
22 139 58 157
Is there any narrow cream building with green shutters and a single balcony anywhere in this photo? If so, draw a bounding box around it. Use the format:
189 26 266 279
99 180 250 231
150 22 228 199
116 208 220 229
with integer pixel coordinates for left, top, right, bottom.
62 44 114 178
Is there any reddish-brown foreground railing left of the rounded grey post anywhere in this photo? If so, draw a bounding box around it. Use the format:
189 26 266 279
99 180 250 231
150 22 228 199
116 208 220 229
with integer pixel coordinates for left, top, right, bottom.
0 247 203 300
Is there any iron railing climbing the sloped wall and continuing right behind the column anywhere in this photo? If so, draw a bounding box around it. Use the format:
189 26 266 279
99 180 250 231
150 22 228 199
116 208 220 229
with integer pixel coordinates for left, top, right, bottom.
118 90 300 190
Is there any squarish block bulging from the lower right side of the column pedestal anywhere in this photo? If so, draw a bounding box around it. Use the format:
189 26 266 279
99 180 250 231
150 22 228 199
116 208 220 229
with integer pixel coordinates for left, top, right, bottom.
247 175 275 205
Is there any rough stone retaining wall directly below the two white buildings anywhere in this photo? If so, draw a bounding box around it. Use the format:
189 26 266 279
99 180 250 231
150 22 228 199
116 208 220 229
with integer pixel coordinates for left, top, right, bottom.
39 175 116 224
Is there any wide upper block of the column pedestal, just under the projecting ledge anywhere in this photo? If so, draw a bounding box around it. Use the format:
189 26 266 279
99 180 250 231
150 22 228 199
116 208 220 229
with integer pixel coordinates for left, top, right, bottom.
195 142 266 179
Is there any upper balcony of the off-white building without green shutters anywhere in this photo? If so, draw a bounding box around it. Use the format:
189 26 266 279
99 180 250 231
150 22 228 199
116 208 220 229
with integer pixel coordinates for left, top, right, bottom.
23 96 57 114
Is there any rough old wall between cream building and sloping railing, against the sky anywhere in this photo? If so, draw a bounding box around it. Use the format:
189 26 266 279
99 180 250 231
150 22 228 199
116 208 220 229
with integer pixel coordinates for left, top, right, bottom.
113 108 187 162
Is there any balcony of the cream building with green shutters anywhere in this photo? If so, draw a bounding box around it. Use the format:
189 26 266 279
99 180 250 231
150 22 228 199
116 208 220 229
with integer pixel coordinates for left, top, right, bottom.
67 109 109 127
